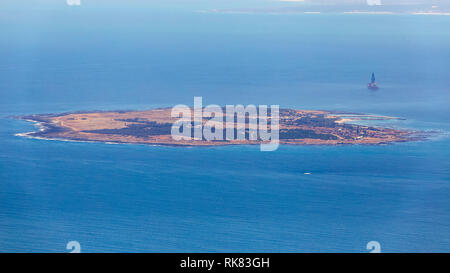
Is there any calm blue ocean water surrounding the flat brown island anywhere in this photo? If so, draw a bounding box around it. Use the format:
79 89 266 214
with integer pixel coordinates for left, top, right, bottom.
0 1 450 252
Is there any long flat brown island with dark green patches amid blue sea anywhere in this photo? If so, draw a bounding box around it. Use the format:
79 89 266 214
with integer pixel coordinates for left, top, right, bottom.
16 108 423 146
